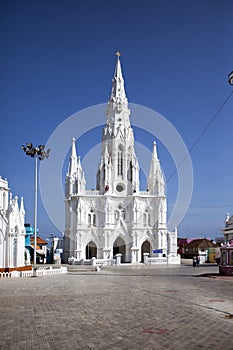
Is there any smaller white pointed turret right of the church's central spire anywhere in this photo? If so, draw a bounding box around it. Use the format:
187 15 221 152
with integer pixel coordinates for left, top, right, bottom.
148 141 165 196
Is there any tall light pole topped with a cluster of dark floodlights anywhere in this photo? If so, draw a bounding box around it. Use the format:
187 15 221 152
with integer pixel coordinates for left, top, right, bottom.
21 143 50 277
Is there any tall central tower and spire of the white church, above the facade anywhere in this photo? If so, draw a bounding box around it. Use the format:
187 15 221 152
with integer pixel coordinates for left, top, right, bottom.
96 52 139 196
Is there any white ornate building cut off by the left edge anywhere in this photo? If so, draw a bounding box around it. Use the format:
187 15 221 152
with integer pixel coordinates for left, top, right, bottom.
0 177 25 269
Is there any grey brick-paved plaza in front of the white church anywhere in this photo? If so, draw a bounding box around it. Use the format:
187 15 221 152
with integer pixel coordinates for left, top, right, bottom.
0 264 233 350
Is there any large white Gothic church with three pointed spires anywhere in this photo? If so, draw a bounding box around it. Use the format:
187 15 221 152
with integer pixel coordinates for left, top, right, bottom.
64 53 180 264
